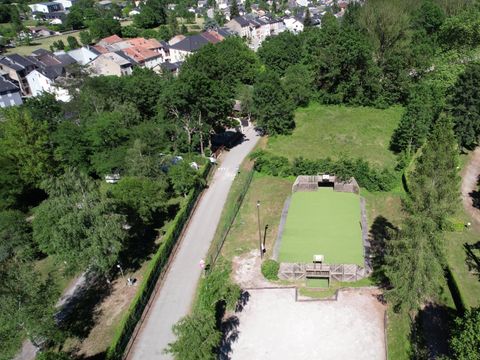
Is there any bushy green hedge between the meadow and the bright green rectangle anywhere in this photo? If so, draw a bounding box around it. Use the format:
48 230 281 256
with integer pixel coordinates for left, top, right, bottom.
251 150 400 191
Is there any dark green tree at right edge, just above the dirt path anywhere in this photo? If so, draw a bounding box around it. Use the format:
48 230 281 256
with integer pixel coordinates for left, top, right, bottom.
448 63 480 149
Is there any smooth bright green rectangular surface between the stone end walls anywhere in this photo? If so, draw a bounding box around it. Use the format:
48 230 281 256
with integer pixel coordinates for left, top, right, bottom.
279 188 364 266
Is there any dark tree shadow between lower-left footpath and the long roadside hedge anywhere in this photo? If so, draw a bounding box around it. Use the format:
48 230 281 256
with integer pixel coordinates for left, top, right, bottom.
55 274 111 339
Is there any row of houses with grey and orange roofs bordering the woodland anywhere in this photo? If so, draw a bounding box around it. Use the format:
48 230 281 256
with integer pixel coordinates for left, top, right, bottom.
0 29 232 108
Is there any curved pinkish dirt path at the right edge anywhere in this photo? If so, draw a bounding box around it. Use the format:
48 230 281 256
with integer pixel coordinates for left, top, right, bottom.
461 146 480 231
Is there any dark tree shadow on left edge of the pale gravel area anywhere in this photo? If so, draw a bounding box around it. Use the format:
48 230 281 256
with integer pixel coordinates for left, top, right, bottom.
217 291 250 360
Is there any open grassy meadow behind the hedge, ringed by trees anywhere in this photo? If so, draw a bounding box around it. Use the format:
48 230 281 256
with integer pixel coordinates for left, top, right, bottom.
267 103 403 166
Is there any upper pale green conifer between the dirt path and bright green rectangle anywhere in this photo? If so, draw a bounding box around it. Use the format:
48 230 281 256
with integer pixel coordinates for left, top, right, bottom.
406 116 460 229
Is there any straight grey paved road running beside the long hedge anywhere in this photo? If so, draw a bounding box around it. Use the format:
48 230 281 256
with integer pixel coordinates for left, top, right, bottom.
128 128 259 360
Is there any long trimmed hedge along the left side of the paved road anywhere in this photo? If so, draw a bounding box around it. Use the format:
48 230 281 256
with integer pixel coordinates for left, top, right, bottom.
106 163 211 359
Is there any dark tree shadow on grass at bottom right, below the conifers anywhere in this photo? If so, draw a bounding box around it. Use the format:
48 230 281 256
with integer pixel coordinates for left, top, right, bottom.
410 303 455 360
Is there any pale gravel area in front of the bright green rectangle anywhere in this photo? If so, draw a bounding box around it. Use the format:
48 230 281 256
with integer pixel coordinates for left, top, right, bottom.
231 289 385 360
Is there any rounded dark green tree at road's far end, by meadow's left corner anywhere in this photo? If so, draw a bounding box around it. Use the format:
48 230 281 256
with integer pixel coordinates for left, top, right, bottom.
253 71 295 135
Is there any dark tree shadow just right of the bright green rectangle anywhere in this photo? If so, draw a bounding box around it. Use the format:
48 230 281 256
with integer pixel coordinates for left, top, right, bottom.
367 215 399 286
